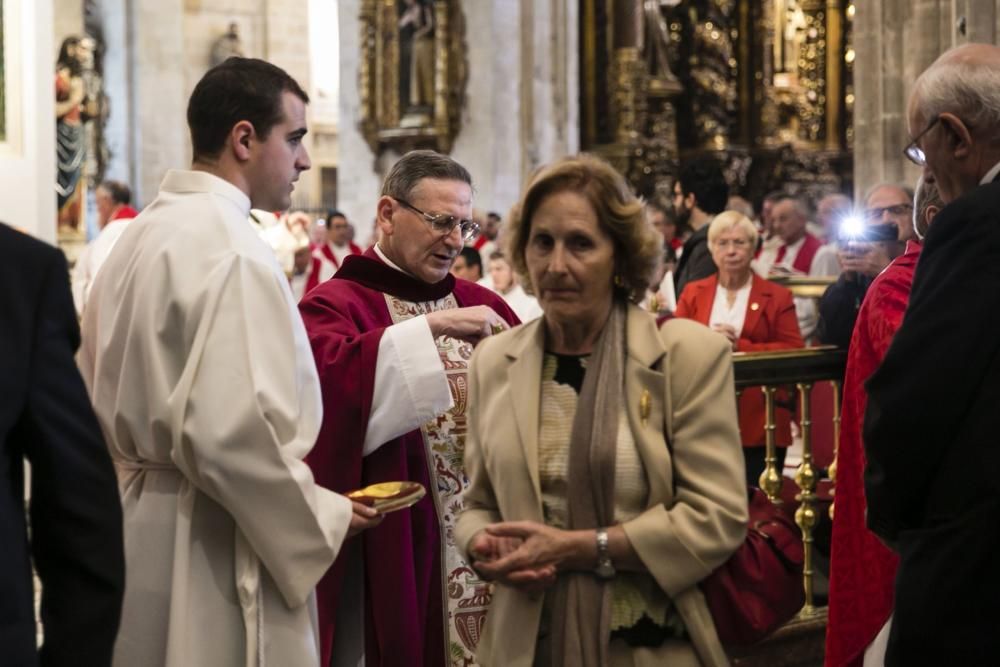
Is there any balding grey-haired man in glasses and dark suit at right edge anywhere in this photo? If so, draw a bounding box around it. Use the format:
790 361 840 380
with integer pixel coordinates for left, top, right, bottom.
864 44 1000 665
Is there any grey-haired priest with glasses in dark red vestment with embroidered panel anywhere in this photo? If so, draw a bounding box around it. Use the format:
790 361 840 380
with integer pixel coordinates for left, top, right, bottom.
300 151 519 667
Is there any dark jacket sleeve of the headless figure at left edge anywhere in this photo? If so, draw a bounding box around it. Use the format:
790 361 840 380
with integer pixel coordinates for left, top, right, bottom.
21 252 125 666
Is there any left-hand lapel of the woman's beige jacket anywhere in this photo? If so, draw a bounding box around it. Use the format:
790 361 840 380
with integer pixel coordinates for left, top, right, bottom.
506 318 545 521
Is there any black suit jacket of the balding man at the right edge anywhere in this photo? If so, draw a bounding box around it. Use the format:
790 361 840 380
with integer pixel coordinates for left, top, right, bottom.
864 185 1000 543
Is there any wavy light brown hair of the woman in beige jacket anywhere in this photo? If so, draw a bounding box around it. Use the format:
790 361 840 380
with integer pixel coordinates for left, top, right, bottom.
507 153 663 303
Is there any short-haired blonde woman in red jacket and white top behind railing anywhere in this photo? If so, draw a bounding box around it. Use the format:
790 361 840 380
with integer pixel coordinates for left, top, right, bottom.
674 211 803 485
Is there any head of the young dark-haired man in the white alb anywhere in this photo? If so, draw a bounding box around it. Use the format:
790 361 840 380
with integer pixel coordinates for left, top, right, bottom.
187 56 312 211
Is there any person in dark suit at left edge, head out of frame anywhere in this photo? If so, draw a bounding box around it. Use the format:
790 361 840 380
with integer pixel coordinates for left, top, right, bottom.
0 224 125 667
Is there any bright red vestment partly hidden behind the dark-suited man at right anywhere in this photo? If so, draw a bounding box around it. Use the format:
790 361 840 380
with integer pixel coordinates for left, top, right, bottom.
826 241 921 667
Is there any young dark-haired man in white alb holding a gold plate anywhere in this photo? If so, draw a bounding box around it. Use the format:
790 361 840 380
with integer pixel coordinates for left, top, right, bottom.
79 58 379 667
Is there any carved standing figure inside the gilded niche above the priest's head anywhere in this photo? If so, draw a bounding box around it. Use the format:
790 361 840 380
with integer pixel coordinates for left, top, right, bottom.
399 0 434 126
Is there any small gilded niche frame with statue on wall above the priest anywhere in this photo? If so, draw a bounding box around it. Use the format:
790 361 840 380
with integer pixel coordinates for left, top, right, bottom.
358 0 468 155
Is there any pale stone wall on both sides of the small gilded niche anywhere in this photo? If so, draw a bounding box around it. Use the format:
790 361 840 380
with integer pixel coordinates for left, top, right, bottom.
337 0 579 240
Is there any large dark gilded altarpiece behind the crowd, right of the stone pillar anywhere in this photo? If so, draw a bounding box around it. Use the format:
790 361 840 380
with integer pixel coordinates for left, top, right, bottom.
580 0 854 198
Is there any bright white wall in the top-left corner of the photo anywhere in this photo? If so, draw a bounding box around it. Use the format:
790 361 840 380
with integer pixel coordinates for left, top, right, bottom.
0 0 57 243
